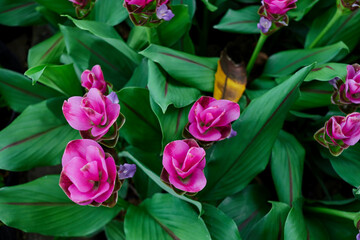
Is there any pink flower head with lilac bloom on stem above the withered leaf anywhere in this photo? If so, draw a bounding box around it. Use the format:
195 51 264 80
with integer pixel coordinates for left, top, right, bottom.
258 0 297 34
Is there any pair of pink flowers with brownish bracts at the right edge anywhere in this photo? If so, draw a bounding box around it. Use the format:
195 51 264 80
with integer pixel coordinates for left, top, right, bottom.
314 64 360 156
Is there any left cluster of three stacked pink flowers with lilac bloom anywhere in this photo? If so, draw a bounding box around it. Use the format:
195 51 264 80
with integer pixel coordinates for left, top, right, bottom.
59 65 136 207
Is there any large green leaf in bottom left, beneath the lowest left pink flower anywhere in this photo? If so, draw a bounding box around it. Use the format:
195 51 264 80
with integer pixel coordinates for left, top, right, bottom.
0 175 126 237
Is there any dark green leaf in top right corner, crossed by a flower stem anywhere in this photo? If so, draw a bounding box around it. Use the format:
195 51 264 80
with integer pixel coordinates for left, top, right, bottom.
305 7 360 50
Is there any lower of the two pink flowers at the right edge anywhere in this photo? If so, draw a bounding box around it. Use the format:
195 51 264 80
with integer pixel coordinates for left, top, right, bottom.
325 112 360 148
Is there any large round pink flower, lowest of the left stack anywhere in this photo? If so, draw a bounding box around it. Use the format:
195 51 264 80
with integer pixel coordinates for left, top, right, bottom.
59 139 117 206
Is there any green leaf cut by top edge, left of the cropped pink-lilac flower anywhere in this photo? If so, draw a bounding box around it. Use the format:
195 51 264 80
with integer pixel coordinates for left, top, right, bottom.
90 0 129 26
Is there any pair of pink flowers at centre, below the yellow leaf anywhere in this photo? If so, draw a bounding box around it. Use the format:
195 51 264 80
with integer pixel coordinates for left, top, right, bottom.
161 97 240 193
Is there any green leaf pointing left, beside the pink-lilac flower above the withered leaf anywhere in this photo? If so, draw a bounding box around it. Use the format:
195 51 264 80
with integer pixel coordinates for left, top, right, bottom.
214 6 260 34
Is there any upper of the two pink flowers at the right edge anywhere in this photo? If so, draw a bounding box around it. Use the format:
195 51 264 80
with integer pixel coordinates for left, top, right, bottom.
340 64 360 104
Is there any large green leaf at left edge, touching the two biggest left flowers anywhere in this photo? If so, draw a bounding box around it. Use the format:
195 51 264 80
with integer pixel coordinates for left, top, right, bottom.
0 99 80 171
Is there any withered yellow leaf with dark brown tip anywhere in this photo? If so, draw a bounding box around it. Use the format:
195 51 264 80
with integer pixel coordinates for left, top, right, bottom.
214 49 247 102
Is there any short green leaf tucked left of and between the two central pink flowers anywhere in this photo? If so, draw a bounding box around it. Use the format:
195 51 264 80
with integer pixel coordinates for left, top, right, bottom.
150 99 191 149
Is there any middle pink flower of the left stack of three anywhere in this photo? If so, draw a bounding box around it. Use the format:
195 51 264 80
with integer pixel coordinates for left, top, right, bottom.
62 88 120 140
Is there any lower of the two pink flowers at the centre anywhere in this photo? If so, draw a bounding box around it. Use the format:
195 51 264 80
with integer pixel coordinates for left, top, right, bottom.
161 139 206 193
